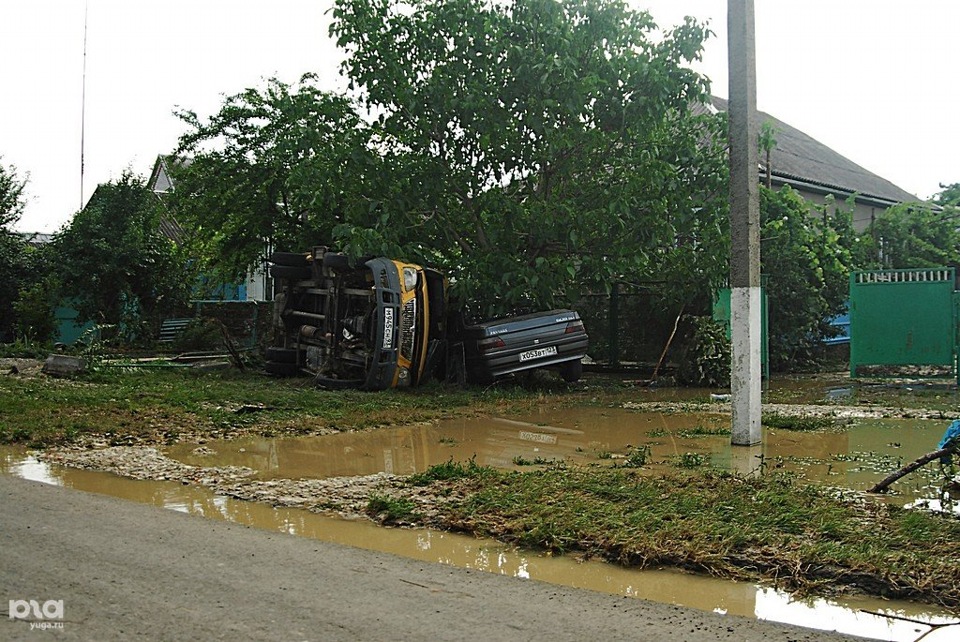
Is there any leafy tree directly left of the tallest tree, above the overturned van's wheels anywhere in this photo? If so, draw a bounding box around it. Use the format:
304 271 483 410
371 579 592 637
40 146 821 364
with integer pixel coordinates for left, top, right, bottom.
172 75 375 280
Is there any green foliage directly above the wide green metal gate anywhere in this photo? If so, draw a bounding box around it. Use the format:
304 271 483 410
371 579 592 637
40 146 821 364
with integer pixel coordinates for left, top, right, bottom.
867 202 960 269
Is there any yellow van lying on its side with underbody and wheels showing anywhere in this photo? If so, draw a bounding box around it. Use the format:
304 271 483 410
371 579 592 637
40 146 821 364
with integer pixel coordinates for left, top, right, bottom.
267 247 447 390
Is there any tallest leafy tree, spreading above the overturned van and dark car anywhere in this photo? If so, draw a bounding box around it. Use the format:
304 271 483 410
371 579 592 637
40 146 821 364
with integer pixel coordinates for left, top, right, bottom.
332 0 726 315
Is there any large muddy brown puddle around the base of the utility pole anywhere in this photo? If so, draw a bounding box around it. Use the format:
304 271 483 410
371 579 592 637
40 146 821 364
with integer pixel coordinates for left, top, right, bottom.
166 408 960 510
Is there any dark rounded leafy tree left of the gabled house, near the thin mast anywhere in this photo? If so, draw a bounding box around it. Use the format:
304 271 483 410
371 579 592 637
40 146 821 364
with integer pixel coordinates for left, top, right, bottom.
52 172 194 338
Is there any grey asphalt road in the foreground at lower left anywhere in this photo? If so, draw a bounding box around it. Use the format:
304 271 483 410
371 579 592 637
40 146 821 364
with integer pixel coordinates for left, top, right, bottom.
0 475 862 642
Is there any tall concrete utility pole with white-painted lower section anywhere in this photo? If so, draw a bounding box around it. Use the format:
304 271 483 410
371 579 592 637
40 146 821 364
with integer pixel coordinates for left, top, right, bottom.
727 0 761 446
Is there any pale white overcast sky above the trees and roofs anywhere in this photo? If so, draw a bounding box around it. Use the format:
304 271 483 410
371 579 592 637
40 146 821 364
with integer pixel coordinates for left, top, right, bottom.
0 0 960 232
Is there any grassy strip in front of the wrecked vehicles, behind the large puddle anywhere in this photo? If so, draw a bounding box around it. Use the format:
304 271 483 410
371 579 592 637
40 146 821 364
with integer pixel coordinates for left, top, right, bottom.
0 368 616 447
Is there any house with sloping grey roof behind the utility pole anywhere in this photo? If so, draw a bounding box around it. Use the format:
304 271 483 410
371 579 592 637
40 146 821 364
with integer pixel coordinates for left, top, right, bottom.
712 97 920 231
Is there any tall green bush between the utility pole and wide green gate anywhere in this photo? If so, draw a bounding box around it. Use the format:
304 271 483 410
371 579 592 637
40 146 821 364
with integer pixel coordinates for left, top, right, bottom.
760 187 862 370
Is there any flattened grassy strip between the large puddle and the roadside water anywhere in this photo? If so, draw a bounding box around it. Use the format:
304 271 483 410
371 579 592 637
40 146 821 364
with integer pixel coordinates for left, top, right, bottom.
394 464 960 609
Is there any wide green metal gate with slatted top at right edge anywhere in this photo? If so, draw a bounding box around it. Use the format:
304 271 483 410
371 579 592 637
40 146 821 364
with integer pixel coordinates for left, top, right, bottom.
850 268 958 377
